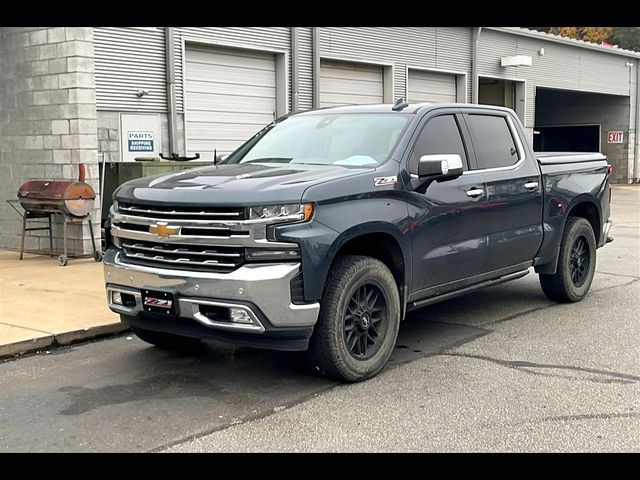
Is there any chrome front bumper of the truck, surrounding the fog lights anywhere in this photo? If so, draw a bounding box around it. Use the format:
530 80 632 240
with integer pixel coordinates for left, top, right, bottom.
103 248 320 333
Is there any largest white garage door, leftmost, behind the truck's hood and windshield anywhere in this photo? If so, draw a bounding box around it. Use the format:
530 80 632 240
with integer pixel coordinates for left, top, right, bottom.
185 48 276 161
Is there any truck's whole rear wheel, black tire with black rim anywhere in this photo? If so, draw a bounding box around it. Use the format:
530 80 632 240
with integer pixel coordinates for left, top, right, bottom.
540 217 596 302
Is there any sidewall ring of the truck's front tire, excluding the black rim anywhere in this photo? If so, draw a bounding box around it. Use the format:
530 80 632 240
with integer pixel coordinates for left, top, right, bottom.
331 264 400 379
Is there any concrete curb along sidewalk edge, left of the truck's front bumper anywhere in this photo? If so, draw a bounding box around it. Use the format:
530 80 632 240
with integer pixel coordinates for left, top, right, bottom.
0 322 129 359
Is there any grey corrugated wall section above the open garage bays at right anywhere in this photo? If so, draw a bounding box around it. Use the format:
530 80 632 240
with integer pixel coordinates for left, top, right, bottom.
478 29 630 128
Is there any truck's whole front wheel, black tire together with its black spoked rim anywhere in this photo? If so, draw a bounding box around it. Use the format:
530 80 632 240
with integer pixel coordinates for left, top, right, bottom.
307 255 400 382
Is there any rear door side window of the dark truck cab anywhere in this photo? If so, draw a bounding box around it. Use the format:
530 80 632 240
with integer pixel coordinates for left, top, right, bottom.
468 114 518 169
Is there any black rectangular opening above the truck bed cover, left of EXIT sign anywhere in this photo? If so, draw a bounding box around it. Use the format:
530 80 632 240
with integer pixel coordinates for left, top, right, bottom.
533 125 600 152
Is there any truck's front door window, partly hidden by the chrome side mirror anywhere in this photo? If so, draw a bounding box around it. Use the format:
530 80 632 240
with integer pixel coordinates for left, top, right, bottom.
409 115 468 172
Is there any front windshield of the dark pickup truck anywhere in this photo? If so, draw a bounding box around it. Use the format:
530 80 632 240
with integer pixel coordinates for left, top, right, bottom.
225 113 408 167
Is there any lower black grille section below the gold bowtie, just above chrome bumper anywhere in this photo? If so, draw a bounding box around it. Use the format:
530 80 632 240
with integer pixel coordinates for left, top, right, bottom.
122 239 244 272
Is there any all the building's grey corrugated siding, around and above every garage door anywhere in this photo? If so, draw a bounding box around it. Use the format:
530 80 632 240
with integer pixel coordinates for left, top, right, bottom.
94 27 638 180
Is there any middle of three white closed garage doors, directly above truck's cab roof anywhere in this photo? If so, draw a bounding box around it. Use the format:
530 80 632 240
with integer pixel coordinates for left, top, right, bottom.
320 60 383 107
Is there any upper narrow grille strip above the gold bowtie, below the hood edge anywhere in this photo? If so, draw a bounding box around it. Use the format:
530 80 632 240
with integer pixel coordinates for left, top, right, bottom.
118 202 247 220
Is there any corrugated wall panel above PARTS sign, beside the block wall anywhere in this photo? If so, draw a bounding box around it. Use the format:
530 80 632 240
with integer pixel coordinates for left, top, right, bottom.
93 27 167 112
